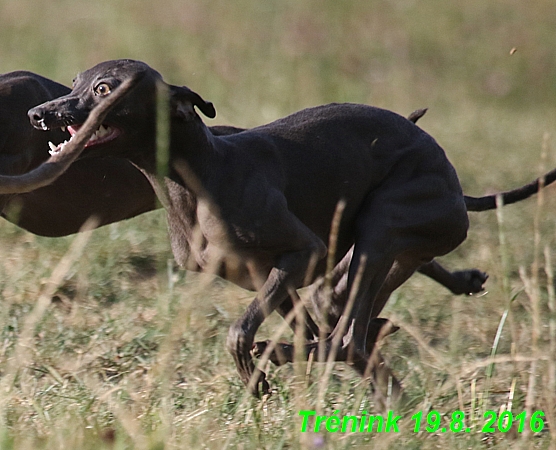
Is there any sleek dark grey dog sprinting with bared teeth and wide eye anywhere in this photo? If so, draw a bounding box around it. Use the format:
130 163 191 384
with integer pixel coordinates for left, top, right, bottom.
29 60 556 395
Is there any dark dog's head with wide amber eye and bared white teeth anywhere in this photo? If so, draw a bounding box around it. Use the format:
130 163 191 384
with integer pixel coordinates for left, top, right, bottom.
28 59 216 162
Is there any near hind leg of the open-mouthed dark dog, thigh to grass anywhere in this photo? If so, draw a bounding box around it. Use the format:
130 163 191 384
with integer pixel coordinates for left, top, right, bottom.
256 178 468 396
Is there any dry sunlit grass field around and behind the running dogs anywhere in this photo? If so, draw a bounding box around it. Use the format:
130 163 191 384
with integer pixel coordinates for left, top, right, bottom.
0 0 556 450
